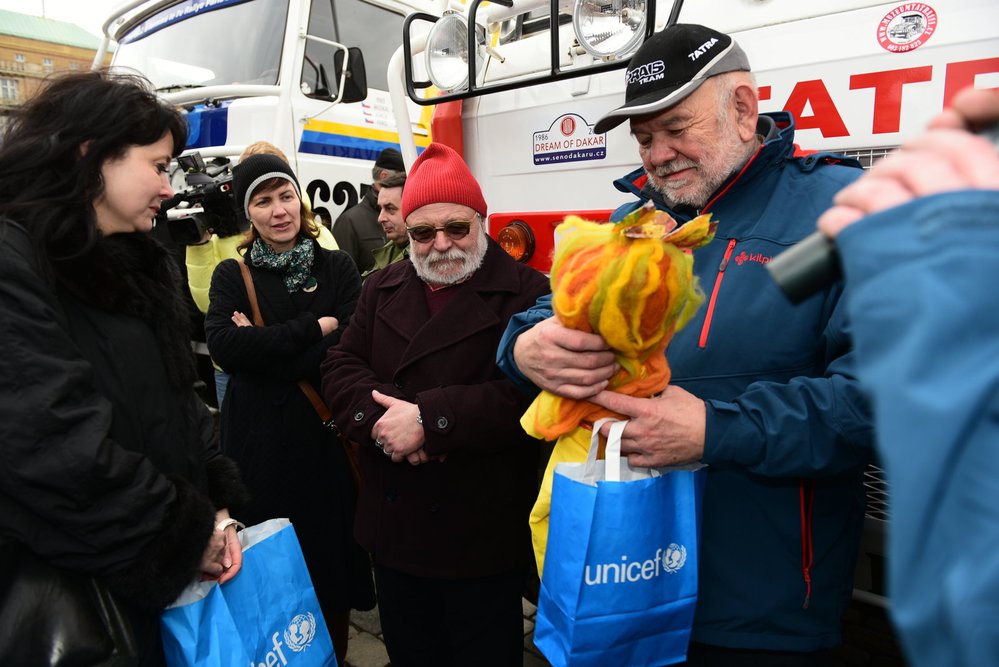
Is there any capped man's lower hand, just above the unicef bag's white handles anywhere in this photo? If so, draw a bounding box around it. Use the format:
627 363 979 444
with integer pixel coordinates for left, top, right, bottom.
590 386 707 468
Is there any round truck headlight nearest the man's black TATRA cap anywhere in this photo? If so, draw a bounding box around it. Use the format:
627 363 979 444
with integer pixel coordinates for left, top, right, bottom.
572 0 646 59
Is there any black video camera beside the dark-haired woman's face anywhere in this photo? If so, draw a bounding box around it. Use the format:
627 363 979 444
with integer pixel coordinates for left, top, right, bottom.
156 153 249 245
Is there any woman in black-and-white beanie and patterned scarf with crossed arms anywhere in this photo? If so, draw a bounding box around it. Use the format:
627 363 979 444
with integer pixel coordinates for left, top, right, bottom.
205 154 374 664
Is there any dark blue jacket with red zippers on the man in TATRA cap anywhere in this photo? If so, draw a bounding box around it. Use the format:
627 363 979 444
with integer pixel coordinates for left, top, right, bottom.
498 112 872 651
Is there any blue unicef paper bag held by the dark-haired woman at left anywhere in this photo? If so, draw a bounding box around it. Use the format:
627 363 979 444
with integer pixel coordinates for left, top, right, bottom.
161 519 337 667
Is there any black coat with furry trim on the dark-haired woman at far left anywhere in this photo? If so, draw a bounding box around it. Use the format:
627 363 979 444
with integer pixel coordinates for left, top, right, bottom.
0 220 245 665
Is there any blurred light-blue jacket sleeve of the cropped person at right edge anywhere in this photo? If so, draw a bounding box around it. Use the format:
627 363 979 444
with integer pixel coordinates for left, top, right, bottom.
837 190 999 667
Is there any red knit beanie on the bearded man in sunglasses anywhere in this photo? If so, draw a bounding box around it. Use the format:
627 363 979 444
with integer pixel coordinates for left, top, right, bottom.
402 143 486 220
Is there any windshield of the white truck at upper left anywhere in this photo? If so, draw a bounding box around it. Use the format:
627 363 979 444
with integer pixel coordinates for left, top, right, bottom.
114 0 288 91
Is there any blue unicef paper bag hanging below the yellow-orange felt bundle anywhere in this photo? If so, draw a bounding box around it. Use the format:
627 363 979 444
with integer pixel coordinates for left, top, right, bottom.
534 420 705 667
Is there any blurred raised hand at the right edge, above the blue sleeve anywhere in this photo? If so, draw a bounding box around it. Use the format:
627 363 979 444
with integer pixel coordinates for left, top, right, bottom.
818 89 999 238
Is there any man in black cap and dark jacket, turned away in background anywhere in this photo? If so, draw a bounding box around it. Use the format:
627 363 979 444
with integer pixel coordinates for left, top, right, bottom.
333 148 406 273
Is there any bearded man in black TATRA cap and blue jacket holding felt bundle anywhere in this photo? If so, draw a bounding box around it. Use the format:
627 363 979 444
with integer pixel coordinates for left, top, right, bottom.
499 25 872 667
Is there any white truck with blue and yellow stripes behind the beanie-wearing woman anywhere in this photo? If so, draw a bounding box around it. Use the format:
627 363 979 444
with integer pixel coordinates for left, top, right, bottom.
94 0 429 225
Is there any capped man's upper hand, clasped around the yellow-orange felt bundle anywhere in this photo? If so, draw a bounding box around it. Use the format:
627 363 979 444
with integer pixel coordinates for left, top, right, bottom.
513 317 617 399
